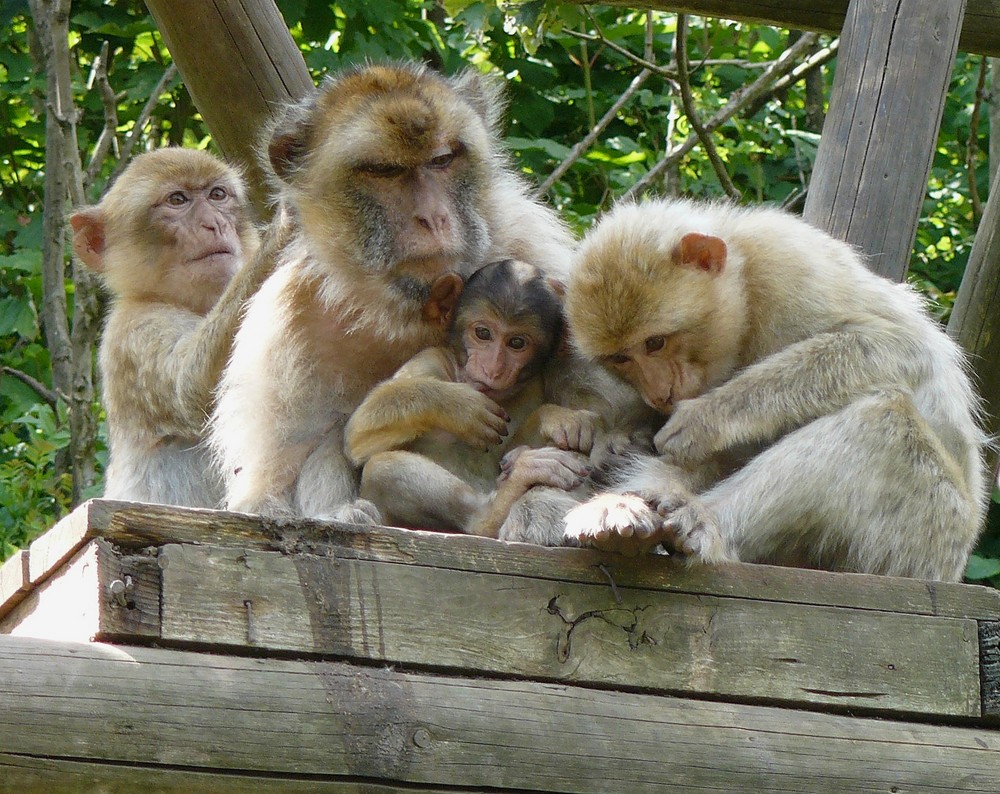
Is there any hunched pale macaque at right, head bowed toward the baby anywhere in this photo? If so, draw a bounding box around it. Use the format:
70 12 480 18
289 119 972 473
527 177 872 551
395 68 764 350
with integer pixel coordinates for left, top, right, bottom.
565 200 986 581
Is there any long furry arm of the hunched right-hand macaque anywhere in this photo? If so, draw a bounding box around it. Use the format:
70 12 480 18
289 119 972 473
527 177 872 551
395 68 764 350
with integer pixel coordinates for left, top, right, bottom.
654 320 926 466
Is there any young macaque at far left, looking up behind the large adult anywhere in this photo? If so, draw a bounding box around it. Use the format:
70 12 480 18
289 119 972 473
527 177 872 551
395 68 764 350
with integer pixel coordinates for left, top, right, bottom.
70 149 270 507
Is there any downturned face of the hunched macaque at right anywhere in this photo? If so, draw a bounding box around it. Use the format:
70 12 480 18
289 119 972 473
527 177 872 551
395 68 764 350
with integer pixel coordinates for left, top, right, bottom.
604 331 707 415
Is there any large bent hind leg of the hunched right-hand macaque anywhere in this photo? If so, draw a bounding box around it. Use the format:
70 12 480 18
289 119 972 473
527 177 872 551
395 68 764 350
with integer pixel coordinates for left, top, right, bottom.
667 392 980 581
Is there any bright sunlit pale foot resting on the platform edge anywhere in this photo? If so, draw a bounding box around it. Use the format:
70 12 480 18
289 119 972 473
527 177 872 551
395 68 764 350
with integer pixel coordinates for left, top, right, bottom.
563 494 664 557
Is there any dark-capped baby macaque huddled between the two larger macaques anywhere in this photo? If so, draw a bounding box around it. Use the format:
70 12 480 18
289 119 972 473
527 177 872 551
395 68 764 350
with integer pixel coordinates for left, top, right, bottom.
347 259 597 537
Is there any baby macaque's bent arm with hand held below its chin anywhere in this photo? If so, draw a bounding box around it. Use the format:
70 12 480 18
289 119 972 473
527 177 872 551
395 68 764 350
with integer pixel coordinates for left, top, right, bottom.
346 348 508 465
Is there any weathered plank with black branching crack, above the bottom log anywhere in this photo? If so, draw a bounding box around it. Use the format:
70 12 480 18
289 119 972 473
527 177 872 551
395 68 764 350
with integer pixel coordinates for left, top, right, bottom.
152 545 980 717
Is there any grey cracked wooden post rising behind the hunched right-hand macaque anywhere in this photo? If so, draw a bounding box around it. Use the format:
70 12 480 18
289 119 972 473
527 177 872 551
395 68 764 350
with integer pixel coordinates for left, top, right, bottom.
803 0 965 281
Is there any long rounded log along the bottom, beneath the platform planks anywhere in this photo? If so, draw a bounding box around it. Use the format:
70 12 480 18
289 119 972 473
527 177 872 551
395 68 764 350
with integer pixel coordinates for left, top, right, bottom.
0 637 1000 794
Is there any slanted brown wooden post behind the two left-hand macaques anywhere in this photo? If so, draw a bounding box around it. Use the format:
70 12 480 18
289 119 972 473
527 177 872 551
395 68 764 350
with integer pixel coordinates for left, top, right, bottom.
146 0 313 216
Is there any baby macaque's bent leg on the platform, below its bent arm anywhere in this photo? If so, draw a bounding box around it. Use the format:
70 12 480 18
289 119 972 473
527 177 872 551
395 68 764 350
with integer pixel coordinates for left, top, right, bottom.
361 450 485 532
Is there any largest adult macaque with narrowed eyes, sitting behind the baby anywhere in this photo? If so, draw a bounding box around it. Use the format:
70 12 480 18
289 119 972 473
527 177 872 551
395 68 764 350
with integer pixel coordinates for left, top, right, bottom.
212 63 575 523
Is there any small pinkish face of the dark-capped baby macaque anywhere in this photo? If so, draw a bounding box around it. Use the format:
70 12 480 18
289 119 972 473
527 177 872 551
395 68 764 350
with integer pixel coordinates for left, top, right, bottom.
461 313 544 404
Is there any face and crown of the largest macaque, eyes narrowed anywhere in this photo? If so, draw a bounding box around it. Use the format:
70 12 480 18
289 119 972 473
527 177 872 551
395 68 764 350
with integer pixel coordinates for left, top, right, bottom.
282 66 490 286
